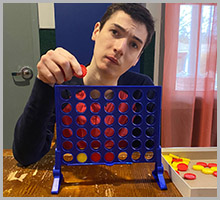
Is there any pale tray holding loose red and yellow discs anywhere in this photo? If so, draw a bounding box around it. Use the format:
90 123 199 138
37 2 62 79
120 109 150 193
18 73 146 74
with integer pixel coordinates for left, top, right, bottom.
162 147 217 197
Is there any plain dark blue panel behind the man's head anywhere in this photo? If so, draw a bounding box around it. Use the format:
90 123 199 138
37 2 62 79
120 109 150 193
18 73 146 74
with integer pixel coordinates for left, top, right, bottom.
55 3 140 72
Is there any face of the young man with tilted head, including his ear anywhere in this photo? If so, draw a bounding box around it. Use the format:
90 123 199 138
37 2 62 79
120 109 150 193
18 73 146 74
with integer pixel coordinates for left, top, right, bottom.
92 11 148 78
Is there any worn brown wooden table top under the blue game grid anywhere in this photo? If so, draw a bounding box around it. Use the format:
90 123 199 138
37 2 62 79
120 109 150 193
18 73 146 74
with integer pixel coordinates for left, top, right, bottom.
3 149 181 197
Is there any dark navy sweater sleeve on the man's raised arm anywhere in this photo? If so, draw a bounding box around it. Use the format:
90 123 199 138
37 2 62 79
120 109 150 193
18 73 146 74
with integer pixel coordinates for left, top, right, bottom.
13 78 55 166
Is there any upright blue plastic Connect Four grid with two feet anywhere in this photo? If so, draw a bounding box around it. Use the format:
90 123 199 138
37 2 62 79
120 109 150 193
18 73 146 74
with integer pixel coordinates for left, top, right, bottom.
51 85 167 194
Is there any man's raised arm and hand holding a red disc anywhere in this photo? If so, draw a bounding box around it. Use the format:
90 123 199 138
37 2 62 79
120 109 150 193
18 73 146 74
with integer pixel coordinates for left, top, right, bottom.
13 48 82 165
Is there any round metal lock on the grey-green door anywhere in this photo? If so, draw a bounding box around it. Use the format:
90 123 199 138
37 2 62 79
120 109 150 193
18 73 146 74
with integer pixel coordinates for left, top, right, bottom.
11 66 33 86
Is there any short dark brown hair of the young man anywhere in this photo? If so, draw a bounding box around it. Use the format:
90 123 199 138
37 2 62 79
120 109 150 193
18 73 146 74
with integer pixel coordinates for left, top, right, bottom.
100 3 154 49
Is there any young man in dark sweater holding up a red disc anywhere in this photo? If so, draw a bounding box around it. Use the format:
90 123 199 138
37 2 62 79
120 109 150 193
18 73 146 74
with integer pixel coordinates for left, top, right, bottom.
13 4 154 166
